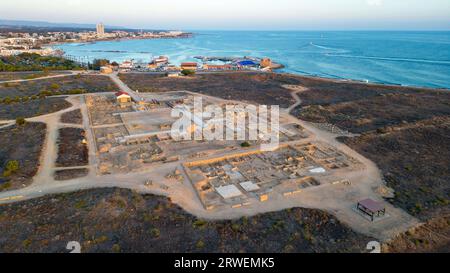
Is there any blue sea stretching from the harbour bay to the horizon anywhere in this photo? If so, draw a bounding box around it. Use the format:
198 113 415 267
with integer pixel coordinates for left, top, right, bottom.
57 31 450 88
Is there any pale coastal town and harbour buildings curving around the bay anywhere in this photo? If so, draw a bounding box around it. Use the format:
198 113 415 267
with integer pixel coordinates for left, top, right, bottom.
0 23 284 73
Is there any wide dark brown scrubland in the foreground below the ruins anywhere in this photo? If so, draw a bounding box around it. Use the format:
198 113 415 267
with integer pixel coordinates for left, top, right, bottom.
0 189 373 253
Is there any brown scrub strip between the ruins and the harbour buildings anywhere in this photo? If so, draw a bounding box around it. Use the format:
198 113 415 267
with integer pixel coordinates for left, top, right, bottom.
120 73 298 107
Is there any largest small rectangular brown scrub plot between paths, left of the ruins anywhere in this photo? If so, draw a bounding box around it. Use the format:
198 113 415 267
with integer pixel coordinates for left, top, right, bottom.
56 128 89 167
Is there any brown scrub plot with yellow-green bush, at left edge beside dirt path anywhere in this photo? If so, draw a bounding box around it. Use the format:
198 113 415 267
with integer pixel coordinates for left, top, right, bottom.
0 122 46 191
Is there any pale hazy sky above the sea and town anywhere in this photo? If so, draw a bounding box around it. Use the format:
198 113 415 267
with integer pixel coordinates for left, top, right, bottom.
0 0 450 30
